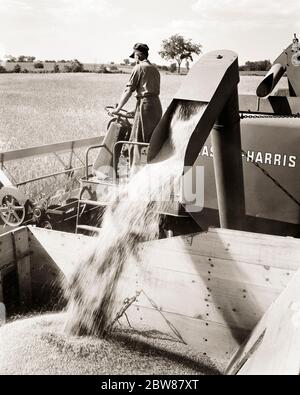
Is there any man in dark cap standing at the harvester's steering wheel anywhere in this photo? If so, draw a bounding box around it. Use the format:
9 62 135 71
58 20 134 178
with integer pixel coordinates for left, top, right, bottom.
111 43 162 172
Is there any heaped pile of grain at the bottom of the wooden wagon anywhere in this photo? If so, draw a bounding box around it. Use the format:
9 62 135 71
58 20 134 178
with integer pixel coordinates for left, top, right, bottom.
0 314 219 375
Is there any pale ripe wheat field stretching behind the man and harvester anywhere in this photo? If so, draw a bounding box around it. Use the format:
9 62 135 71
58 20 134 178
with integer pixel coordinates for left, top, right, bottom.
0 73 286 200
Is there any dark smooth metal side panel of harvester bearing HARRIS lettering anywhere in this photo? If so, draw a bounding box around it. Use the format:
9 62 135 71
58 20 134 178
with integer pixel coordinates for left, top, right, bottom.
195 117 300 236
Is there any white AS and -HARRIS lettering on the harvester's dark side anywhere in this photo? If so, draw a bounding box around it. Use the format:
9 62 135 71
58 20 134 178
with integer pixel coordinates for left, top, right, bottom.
200 145 297 168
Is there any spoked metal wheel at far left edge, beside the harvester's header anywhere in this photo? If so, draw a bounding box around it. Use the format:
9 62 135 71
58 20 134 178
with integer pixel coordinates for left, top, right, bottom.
0 187 27 227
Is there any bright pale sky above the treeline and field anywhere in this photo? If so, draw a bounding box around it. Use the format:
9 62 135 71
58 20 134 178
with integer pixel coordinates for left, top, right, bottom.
0 0 300 64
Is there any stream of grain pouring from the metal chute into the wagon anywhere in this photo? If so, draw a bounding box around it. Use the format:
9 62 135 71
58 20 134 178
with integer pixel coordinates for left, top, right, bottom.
66 101 206 336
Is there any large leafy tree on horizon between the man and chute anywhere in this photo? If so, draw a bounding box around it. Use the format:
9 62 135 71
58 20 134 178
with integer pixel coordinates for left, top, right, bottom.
159 34 202 74
